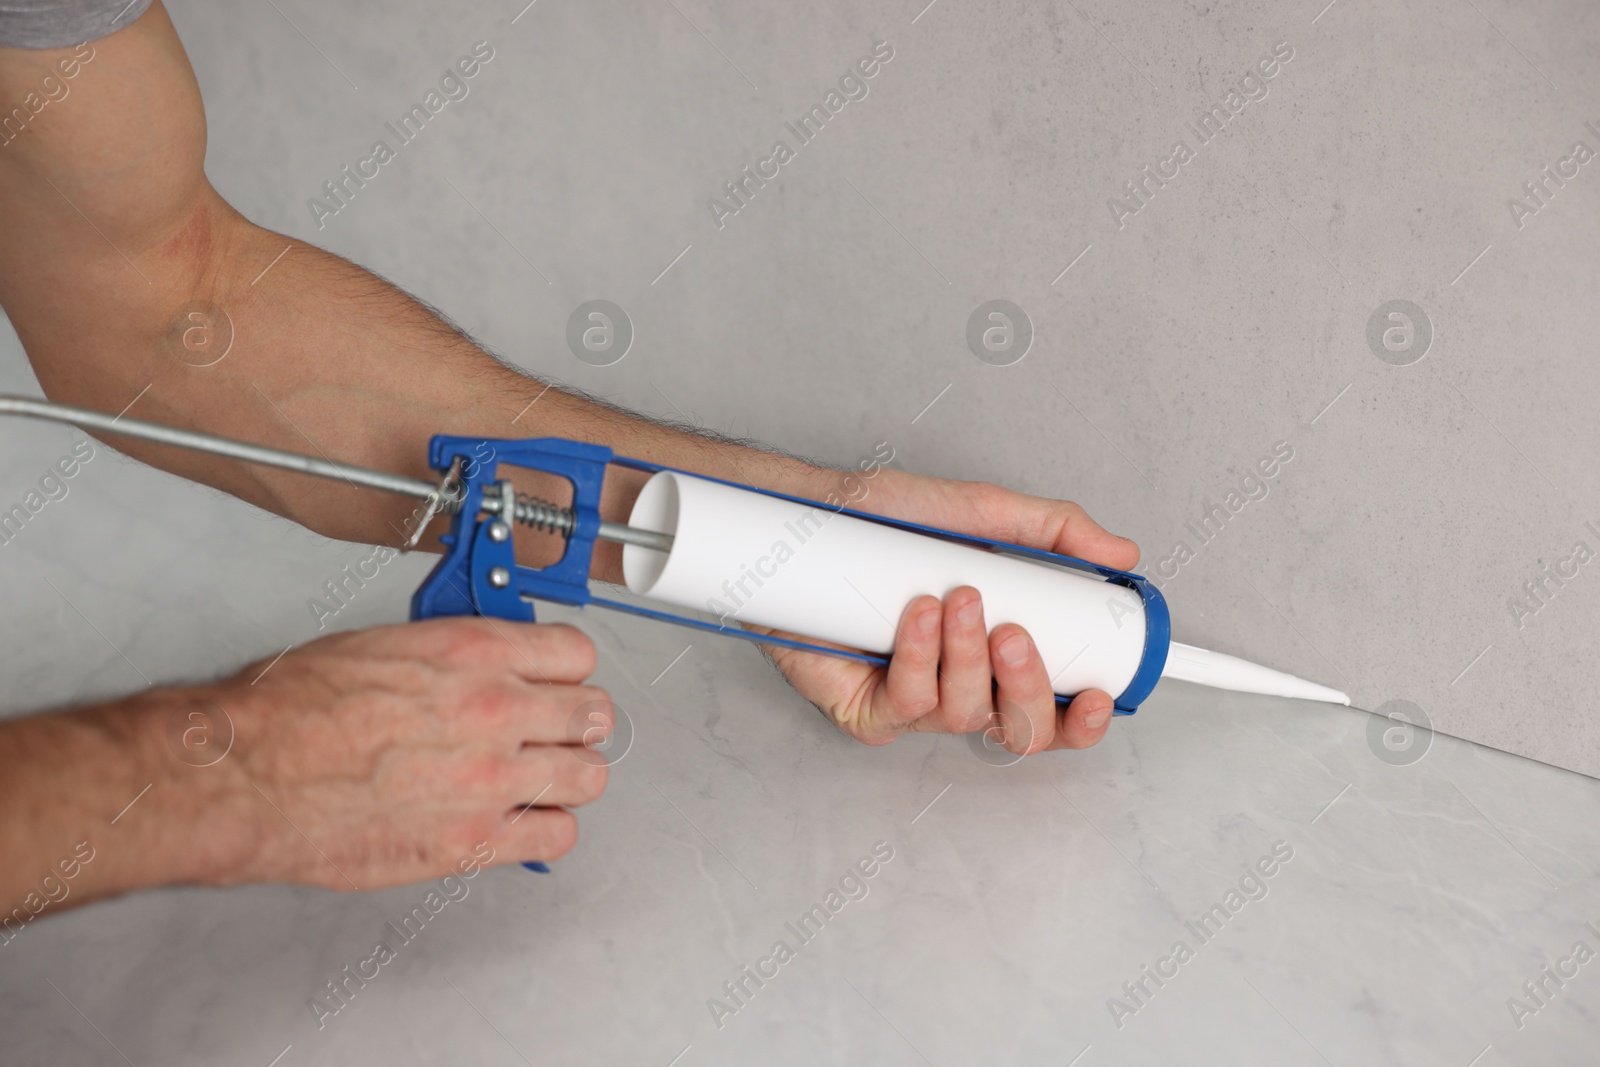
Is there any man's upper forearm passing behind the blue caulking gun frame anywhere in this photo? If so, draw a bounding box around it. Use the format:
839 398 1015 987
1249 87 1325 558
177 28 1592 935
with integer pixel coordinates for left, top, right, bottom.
18 188 826 581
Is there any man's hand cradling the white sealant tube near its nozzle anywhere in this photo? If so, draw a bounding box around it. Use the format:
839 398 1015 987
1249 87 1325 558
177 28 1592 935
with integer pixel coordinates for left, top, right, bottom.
771 469 1139 755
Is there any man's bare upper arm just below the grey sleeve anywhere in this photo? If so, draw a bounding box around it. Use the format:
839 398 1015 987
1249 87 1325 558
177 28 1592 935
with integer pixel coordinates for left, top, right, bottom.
0 0 214 326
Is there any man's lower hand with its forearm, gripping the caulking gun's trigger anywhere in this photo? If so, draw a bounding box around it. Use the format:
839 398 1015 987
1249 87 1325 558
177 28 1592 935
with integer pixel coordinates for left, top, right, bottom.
0 619 614 910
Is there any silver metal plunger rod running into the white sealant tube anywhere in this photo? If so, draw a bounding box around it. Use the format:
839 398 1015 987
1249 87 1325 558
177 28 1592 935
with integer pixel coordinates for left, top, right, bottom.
0 397 672 552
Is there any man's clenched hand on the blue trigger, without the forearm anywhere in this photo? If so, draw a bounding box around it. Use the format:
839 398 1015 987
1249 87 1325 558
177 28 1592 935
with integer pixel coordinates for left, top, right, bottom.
190 619 613 889
